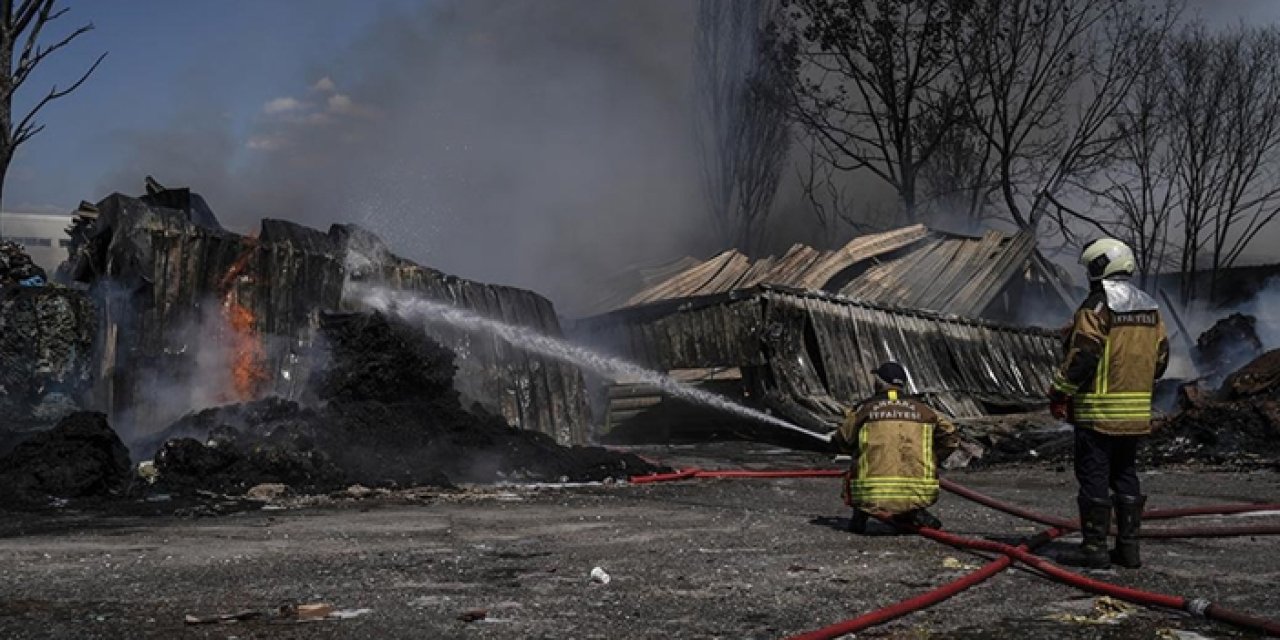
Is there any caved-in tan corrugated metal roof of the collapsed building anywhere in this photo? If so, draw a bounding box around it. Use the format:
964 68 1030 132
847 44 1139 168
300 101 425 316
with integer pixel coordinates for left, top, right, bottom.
611 225 1036 316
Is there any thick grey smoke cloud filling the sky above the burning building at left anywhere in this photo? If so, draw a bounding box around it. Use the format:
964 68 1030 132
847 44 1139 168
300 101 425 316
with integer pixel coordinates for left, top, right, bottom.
106 0 712 314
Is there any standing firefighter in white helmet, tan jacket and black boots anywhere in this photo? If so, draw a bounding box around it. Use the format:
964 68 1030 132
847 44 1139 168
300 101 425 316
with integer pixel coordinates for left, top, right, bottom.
1050 238 1169 568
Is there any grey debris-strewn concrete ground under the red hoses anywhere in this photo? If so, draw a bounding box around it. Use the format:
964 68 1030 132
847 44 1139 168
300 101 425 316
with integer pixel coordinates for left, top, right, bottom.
0 444 1280 639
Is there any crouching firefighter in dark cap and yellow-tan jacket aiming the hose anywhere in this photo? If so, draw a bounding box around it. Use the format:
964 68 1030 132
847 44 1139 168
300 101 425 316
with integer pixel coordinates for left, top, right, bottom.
832 362 960 534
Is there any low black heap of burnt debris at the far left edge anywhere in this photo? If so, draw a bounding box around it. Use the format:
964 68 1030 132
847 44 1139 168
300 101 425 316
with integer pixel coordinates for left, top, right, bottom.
0 411 131 504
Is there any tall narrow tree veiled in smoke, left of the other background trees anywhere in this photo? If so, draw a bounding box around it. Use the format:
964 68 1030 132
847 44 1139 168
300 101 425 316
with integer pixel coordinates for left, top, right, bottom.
695 0 790 253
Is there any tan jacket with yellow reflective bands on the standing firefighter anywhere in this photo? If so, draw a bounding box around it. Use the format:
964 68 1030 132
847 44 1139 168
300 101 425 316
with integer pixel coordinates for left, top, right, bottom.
1051 279 1169 435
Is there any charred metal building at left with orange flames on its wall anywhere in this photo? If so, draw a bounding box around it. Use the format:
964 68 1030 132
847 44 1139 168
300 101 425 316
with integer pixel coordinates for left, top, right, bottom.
70 180 589 443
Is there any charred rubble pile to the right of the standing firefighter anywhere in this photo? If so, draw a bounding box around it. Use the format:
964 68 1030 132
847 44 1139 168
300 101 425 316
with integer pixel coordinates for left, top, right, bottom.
1148 349 1280 466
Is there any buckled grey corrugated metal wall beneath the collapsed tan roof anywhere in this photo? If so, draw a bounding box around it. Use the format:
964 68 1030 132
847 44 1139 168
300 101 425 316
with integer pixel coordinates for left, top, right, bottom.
572 285 1060 429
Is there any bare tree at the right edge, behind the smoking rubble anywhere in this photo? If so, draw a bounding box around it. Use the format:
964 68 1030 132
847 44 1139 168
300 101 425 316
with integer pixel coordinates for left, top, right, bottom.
1166 26 1280 303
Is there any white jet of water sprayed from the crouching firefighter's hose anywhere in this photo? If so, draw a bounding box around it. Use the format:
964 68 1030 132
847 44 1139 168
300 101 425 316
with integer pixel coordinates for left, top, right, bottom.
360 287 831 443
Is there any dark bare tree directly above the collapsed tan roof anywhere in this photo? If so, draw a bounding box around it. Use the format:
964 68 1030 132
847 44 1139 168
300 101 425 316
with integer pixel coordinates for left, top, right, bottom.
780 0 960 221
